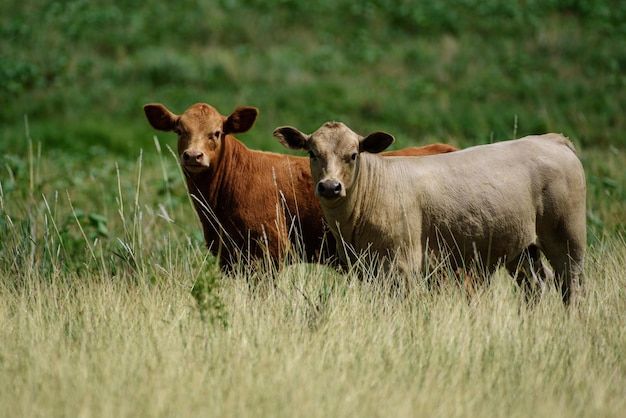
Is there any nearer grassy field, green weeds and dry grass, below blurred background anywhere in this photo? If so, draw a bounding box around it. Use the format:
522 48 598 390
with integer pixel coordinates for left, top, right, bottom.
0 136 626 417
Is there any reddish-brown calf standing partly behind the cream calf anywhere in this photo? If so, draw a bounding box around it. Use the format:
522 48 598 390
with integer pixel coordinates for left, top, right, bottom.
144 103 456 270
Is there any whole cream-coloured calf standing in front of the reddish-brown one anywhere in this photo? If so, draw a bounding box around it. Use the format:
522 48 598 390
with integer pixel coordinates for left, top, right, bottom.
274 122 586 303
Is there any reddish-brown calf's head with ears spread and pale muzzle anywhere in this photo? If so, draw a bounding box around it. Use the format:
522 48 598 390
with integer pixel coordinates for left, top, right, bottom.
143 103 258 173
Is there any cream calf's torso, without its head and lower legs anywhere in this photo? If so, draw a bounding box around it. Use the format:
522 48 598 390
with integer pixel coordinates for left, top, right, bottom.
332 135 585 269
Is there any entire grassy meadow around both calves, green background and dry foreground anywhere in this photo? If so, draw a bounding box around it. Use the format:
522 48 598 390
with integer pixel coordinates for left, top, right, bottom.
0 0 626 417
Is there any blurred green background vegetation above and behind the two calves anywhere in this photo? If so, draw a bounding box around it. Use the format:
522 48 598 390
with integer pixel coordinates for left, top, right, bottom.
0 0 626 158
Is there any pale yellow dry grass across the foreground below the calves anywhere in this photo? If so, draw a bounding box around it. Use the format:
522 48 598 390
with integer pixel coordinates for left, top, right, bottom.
0 235 626 417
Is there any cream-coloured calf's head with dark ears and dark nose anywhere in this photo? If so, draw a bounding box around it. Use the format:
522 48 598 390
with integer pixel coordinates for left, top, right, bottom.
274 122 394 199
